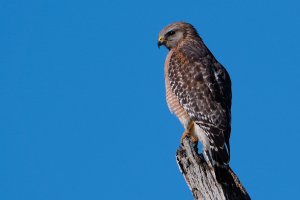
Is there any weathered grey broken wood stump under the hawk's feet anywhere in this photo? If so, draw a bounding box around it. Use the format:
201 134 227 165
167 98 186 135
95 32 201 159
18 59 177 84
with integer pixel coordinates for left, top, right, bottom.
176 137 250 200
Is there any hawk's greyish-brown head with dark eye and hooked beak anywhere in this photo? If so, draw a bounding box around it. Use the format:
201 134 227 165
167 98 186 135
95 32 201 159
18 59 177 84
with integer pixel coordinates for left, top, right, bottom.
157 22 198 50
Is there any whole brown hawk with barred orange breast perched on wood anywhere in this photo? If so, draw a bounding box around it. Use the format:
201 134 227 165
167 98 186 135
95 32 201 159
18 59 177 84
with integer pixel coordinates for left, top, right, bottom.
158 22 231 181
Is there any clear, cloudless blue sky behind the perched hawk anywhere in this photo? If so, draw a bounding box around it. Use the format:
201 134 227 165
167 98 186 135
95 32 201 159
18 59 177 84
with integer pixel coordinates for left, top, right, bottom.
0 0 300 200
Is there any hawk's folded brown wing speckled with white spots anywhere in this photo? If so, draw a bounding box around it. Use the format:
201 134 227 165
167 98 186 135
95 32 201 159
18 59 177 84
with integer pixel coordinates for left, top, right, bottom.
169 41 231 164
